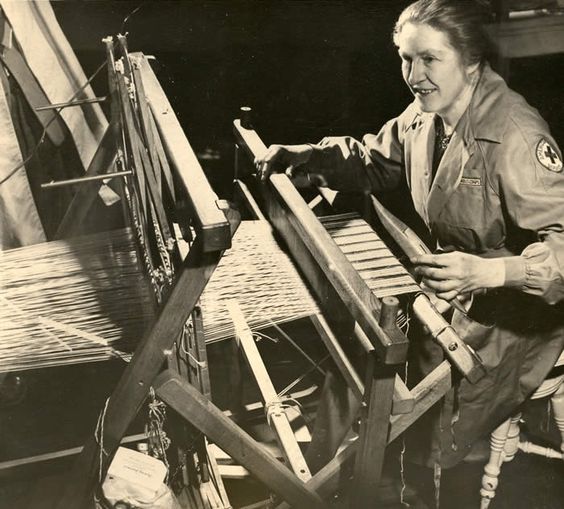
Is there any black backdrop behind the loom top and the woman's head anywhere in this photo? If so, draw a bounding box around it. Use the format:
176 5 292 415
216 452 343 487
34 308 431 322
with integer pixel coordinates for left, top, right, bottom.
53 0 564 196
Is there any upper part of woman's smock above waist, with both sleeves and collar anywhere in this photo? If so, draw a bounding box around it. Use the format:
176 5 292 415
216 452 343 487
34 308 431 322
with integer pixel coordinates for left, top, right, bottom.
308 65 564 304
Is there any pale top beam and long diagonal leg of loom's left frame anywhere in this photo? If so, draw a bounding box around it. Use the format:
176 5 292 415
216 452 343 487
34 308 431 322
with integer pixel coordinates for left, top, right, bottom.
57 44 236 509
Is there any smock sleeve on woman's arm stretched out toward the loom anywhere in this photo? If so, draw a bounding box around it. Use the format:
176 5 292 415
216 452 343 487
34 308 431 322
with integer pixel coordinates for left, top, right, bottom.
307 108 413 192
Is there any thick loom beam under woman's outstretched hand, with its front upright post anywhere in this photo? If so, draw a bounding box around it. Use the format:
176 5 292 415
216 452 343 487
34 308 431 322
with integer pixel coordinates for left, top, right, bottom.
234 120 408 507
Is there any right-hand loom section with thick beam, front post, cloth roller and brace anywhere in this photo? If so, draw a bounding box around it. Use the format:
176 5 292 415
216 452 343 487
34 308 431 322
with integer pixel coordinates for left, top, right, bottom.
234 115 484 507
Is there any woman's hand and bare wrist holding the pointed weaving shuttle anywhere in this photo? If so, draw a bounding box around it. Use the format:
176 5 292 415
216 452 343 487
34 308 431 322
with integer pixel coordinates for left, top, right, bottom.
411 251 505 301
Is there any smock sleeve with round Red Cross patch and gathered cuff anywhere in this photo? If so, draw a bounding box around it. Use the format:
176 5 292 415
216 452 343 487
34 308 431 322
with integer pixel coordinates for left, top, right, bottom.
496 115 564 304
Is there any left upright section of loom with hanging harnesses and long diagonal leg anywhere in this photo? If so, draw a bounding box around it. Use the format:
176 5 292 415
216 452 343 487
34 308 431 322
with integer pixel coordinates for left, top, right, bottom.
48 36 239 509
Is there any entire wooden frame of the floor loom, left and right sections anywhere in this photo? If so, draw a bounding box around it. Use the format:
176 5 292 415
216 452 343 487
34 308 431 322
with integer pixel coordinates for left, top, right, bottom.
36 34 479 509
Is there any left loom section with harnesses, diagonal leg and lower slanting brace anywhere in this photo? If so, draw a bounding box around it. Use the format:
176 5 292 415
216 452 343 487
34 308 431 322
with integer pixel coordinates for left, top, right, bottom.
49 38 362 508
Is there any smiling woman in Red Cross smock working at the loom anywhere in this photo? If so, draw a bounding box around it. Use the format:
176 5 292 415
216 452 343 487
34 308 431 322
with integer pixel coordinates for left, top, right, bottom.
257 0 564 466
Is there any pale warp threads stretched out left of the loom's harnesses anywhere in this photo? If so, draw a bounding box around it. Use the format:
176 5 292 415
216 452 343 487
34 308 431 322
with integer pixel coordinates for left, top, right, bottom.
0 229 154 372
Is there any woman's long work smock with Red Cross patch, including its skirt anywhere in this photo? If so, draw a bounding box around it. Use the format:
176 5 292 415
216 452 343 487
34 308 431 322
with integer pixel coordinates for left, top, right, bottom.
308 66 564 466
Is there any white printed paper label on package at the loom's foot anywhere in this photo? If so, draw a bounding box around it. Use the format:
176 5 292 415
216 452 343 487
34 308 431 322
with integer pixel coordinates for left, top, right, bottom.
108 447 166 492
